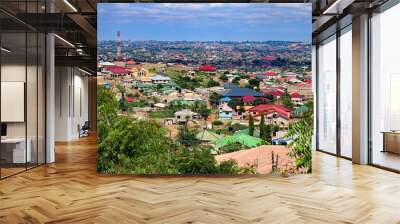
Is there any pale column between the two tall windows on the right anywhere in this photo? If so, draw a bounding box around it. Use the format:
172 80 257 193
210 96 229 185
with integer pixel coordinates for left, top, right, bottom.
352 15 368 164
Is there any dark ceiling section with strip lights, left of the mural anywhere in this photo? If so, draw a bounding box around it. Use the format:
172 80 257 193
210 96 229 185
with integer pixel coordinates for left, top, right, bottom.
0 0 97 74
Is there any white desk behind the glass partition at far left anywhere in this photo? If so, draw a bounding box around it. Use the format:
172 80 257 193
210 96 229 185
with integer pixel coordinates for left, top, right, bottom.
1 138 32 163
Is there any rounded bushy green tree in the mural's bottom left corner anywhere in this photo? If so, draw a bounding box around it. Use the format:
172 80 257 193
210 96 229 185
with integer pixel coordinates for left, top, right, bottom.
98 116 178 174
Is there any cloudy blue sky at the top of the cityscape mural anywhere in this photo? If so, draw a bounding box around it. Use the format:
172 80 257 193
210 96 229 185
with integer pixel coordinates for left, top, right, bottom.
97 3 311 41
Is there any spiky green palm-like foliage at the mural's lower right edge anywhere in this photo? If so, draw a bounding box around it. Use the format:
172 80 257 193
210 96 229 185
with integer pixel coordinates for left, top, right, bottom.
286 102 314 172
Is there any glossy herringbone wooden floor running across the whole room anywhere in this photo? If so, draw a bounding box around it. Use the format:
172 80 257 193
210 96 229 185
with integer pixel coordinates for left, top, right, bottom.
0 138 400 224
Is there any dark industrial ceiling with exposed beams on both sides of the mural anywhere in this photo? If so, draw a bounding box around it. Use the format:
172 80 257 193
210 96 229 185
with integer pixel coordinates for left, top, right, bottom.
0 0 394 72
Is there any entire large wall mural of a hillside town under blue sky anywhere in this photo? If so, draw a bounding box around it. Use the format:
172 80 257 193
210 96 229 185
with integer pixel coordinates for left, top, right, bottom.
97 3 313 176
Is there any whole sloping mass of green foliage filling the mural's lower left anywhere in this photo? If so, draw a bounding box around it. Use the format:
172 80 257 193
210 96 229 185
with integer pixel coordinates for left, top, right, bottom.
98 88 255 174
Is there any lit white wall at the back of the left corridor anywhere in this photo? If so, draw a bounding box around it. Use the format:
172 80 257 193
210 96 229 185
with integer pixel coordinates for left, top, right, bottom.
55 67 88 141
